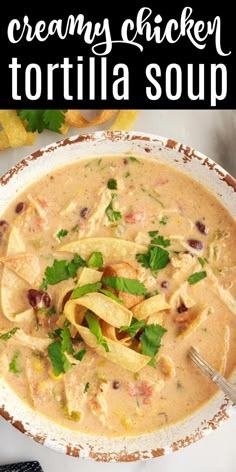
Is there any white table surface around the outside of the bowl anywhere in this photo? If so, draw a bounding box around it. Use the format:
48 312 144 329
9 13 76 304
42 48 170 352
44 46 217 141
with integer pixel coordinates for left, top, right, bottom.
0 110 236 472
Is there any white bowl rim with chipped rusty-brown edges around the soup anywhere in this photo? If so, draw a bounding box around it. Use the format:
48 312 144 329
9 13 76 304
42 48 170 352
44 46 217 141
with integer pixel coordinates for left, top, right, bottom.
0 131 236 462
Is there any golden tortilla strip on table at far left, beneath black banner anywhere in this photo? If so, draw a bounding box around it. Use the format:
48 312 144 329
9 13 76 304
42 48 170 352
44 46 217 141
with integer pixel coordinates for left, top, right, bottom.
0 110 27 147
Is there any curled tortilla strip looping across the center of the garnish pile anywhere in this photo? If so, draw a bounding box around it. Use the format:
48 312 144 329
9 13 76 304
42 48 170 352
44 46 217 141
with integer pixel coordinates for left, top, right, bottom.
64 292 132 328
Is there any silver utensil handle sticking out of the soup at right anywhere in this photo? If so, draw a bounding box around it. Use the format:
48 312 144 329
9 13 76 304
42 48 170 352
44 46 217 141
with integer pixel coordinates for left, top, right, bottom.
188 346 236 403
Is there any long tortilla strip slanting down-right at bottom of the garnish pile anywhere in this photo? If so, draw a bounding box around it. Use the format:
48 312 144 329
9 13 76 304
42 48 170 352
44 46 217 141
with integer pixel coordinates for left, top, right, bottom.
69 318 150 372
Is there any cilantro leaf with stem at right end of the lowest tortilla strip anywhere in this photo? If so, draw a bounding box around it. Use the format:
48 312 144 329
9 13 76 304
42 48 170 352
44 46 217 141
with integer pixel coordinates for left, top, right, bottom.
139 324 167 368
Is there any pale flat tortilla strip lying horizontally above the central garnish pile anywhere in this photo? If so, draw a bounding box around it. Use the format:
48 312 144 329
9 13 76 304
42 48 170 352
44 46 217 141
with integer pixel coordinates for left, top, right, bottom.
58 238 147 263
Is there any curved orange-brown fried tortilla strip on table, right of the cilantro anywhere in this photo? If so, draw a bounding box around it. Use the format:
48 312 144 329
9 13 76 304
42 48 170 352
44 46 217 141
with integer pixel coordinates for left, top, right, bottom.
66 110 118 128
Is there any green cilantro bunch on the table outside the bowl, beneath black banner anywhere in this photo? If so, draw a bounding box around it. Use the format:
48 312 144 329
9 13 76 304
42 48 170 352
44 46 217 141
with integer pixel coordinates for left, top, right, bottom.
17 110 67 133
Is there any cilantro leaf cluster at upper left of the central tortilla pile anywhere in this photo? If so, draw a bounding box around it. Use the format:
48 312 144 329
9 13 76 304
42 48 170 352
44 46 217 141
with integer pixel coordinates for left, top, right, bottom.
44 254 87 285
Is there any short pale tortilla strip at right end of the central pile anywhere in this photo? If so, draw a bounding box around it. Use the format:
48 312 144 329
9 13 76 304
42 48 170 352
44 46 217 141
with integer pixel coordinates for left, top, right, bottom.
132 294 170 320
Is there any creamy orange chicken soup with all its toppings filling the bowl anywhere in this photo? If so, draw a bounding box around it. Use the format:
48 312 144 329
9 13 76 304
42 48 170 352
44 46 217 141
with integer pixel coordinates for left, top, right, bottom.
0 155 236 436
